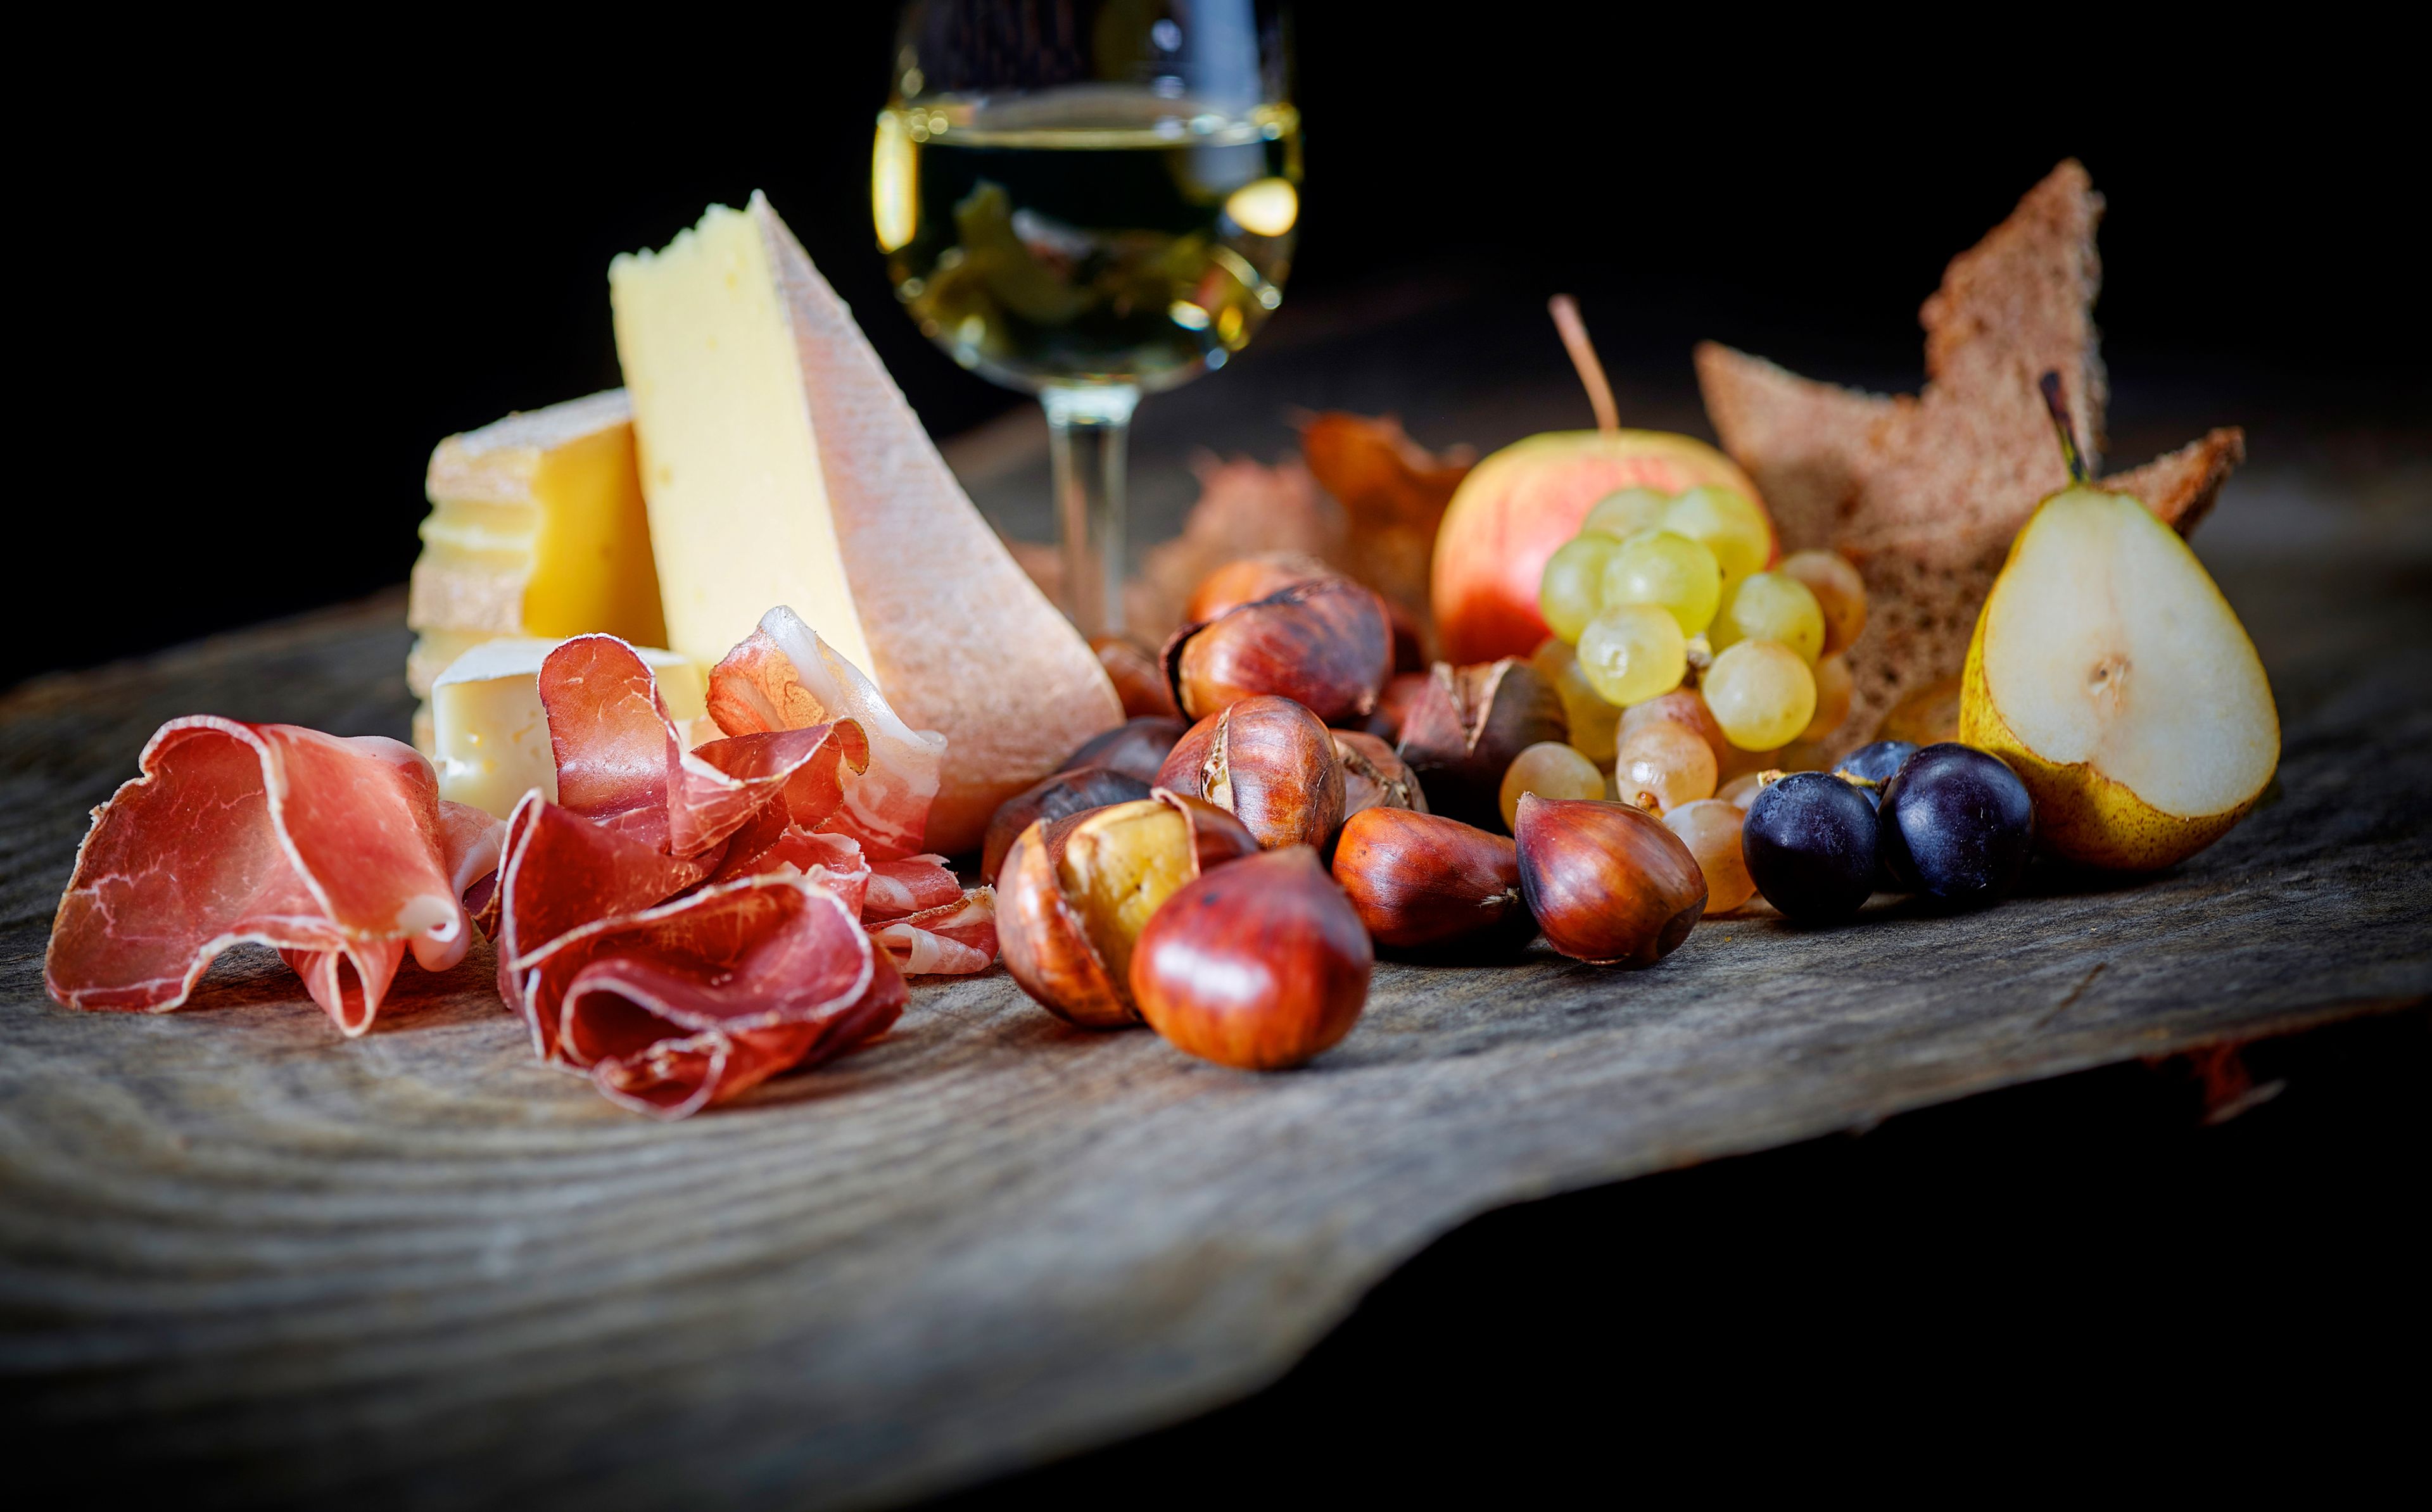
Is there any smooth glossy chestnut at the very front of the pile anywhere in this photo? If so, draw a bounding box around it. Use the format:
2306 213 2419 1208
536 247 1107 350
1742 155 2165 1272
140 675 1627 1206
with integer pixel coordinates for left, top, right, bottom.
1131 846 1376 1072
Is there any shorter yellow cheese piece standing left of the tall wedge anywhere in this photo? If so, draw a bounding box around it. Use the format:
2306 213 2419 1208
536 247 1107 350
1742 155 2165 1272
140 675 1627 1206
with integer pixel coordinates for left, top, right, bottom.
406 389 666 753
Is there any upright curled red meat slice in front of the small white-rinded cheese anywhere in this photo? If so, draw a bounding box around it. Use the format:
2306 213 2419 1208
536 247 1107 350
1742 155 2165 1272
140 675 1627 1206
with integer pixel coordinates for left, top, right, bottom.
538 634 871 855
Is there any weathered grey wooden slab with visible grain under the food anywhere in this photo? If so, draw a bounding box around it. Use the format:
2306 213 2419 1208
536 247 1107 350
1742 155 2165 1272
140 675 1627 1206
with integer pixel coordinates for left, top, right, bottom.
14 476 2432 1507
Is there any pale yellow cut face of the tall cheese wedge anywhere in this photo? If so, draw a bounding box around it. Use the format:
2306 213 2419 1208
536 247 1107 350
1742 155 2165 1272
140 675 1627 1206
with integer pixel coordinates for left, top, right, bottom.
608 204 873 671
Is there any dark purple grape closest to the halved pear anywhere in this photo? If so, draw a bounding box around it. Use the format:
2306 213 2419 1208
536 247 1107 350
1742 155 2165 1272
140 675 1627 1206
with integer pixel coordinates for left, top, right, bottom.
1882 741 2036 904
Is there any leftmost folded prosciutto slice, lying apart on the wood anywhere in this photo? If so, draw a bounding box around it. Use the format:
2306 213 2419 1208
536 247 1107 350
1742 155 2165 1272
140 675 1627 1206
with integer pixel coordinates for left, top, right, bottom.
41 715 501 1036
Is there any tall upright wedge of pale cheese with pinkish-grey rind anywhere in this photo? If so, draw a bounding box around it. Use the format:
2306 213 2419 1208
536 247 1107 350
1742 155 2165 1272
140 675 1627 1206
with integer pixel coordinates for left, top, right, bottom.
608 194 1124 854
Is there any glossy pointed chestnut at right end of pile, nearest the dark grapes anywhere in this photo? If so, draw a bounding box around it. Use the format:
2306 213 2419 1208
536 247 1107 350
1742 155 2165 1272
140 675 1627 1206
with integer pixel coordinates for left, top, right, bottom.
1517 793 1705 965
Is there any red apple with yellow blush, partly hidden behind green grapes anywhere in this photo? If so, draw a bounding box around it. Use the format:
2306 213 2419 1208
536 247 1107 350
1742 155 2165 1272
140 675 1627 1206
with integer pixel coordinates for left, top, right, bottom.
1435 431 1780 666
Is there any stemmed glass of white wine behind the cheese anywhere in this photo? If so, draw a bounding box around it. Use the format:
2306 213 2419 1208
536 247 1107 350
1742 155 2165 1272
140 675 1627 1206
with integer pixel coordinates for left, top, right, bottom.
871 0 1301 634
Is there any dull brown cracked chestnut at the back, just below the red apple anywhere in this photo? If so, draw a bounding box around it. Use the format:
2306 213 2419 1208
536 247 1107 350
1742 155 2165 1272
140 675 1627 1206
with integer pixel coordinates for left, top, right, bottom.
1401 657 1569 831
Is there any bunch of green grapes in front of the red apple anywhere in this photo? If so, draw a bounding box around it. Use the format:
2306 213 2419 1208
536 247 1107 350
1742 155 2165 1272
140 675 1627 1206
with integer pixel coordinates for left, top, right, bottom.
1537 486 1865 807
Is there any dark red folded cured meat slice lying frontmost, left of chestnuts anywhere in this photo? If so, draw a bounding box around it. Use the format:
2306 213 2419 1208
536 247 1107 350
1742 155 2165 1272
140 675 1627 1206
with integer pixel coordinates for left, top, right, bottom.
528 875 904 1118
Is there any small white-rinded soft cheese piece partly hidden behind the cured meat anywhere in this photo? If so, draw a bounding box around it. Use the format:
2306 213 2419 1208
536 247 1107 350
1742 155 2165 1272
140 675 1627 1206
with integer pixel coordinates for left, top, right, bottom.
431 637 707 819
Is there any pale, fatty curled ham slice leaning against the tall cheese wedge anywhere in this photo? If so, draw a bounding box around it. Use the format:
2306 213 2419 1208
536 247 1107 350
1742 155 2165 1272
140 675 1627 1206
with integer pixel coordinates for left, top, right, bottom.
707 605 946 863
